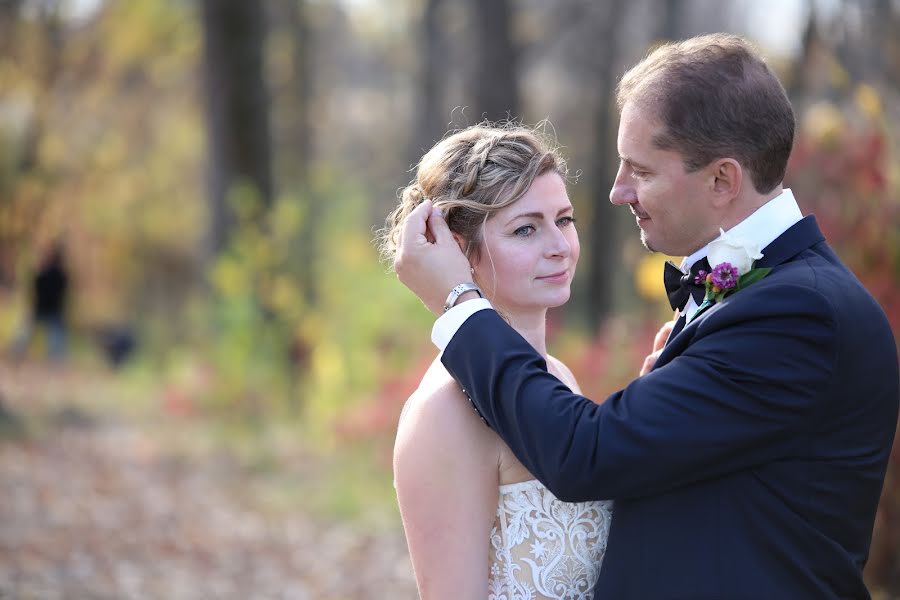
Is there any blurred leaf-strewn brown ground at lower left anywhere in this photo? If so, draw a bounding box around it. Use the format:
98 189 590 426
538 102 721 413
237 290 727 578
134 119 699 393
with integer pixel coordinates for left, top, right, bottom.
0 364 415 600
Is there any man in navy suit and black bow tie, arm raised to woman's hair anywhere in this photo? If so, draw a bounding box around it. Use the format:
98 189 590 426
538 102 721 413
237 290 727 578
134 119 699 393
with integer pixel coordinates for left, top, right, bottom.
395 35 900 600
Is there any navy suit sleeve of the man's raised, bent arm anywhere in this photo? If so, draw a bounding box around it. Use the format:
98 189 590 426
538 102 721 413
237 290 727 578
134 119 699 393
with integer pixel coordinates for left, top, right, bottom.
442 285 840 501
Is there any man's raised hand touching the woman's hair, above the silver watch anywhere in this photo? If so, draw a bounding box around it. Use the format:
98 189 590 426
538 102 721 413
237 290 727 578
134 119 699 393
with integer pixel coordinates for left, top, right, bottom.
394 200 474 315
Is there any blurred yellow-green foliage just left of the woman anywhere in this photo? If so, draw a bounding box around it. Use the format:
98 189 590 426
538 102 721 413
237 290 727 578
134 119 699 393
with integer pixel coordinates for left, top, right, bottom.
192 173 431 442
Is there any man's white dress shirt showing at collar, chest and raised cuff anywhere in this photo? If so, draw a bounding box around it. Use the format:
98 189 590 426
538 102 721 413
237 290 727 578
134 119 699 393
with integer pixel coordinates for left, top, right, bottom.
431 189 803 352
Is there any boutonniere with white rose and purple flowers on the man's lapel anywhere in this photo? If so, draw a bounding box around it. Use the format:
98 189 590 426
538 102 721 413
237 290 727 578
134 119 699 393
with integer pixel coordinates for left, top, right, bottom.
697 229 772 311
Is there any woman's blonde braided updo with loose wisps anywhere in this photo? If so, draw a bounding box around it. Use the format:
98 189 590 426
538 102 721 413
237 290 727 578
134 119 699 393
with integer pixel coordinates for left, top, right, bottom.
377 122 568 264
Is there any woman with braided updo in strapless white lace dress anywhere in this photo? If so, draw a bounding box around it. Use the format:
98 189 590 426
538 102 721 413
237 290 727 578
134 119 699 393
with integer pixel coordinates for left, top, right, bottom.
380 125 612 600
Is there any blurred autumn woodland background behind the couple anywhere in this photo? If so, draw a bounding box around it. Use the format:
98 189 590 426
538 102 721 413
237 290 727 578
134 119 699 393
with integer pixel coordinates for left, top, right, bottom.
0 0 900 599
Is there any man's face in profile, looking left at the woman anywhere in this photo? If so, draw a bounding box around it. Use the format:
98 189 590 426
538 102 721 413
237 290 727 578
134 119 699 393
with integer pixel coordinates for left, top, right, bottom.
609 102 718 256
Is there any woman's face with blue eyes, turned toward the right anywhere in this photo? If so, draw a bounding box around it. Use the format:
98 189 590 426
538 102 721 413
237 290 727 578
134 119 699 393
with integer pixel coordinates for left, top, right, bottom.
473 172 580 312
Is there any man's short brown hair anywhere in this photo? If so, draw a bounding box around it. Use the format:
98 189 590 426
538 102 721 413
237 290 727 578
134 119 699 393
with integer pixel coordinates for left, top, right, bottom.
616 33 794 194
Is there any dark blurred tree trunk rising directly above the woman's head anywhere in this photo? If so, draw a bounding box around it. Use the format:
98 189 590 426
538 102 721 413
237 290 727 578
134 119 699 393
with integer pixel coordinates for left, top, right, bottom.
471 0 520 121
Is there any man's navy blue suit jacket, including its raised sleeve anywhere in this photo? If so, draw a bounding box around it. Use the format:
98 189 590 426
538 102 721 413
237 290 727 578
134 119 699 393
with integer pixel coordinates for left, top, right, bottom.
442 216 900 600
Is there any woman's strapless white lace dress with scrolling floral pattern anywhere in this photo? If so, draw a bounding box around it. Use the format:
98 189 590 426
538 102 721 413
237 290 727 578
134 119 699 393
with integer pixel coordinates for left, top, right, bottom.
488 479 612 600
